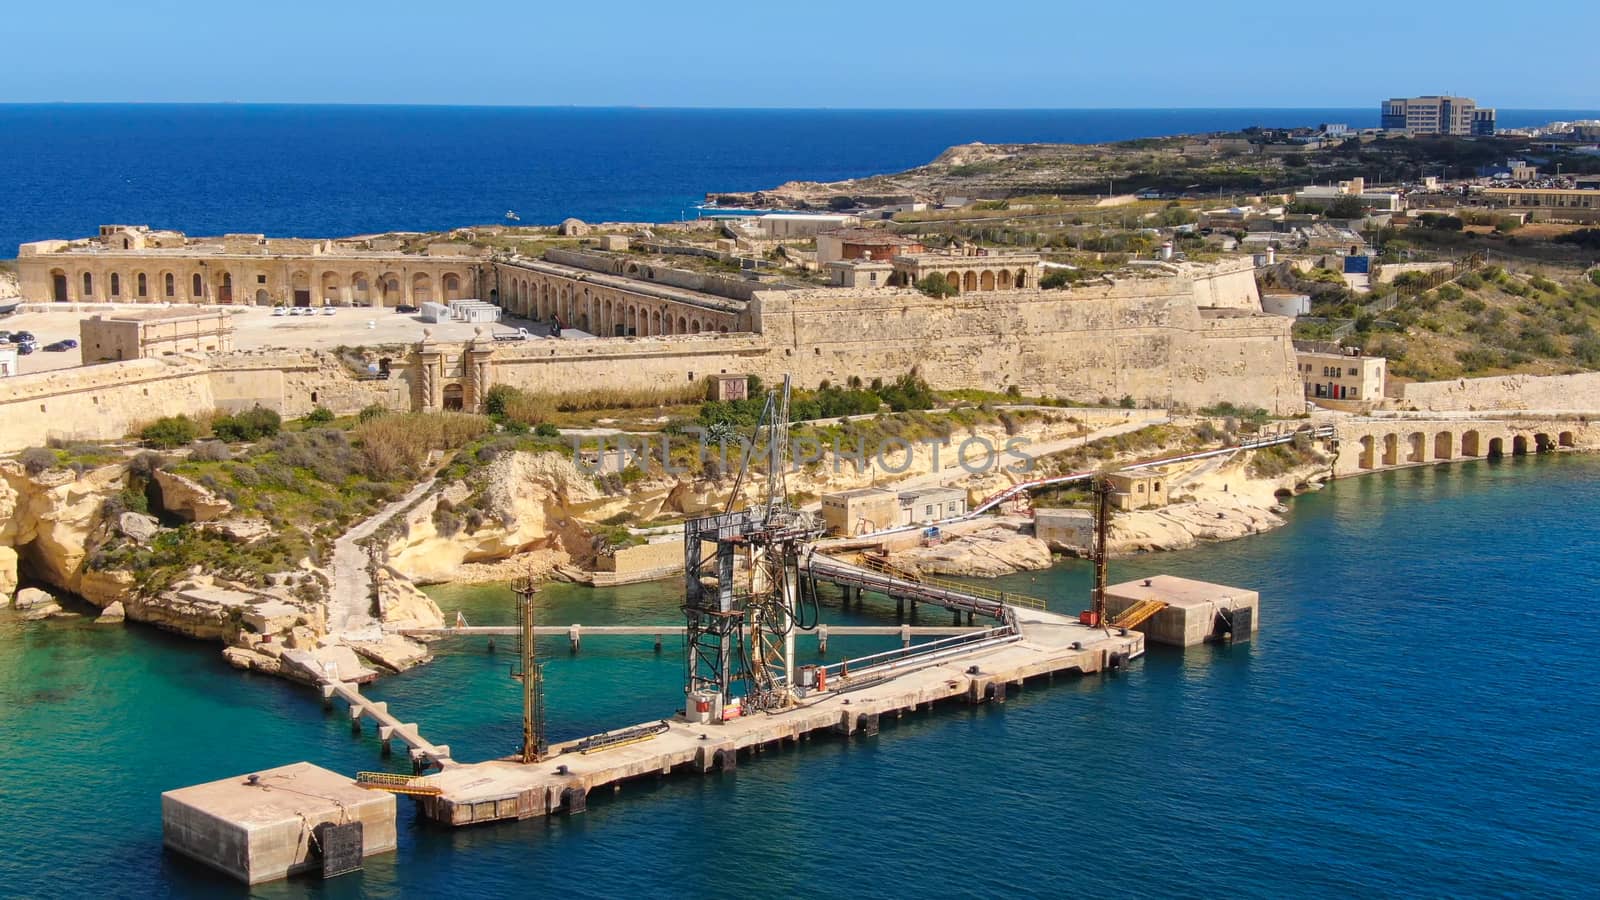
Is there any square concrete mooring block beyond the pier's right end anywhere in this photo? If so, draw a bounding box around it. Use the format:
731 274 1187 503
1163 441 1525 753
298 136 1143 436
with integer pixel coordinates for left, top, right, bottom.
1106 575 1261 647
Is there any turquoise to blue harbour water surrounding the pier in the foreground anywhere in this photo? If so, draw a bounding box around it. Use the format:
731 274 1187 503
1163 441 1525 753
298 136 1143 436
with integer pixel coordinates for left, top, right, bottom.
0 456 1600 897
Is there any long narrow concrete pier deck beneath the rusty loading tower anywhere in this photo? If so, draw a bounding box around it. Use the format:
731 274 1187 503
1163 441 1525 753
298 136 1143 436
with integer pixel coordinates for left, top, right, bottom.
419 609 1144 825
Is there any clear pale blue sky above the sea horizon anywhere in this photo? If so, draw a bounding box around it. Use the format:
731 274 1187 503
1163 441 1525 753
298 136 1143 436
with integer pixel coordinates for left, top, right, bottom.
0 0 1600 109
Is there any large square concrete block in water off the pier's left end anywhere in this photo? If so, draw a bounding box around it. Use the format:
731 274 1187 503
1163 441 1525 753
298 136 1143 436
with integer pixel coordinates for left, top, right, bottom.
162 762 395 884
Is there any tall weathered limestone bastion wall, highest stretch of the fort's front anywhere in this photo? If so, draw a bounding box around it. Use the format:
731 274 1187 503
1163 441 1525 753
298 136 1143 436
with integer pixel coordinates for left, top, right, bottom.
758 279 1304 413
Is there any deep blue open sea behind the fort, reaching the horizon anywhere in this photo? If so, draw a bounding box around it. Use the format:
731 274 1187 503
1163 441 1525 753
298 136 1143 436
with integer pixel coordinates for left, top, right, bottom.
0 102 1597 258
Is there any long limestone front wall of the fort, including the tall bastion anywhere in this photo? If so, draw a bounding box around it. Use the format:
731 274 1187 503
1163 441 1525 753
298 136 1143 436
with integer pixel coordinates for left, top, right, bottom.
0 264 1299 452
